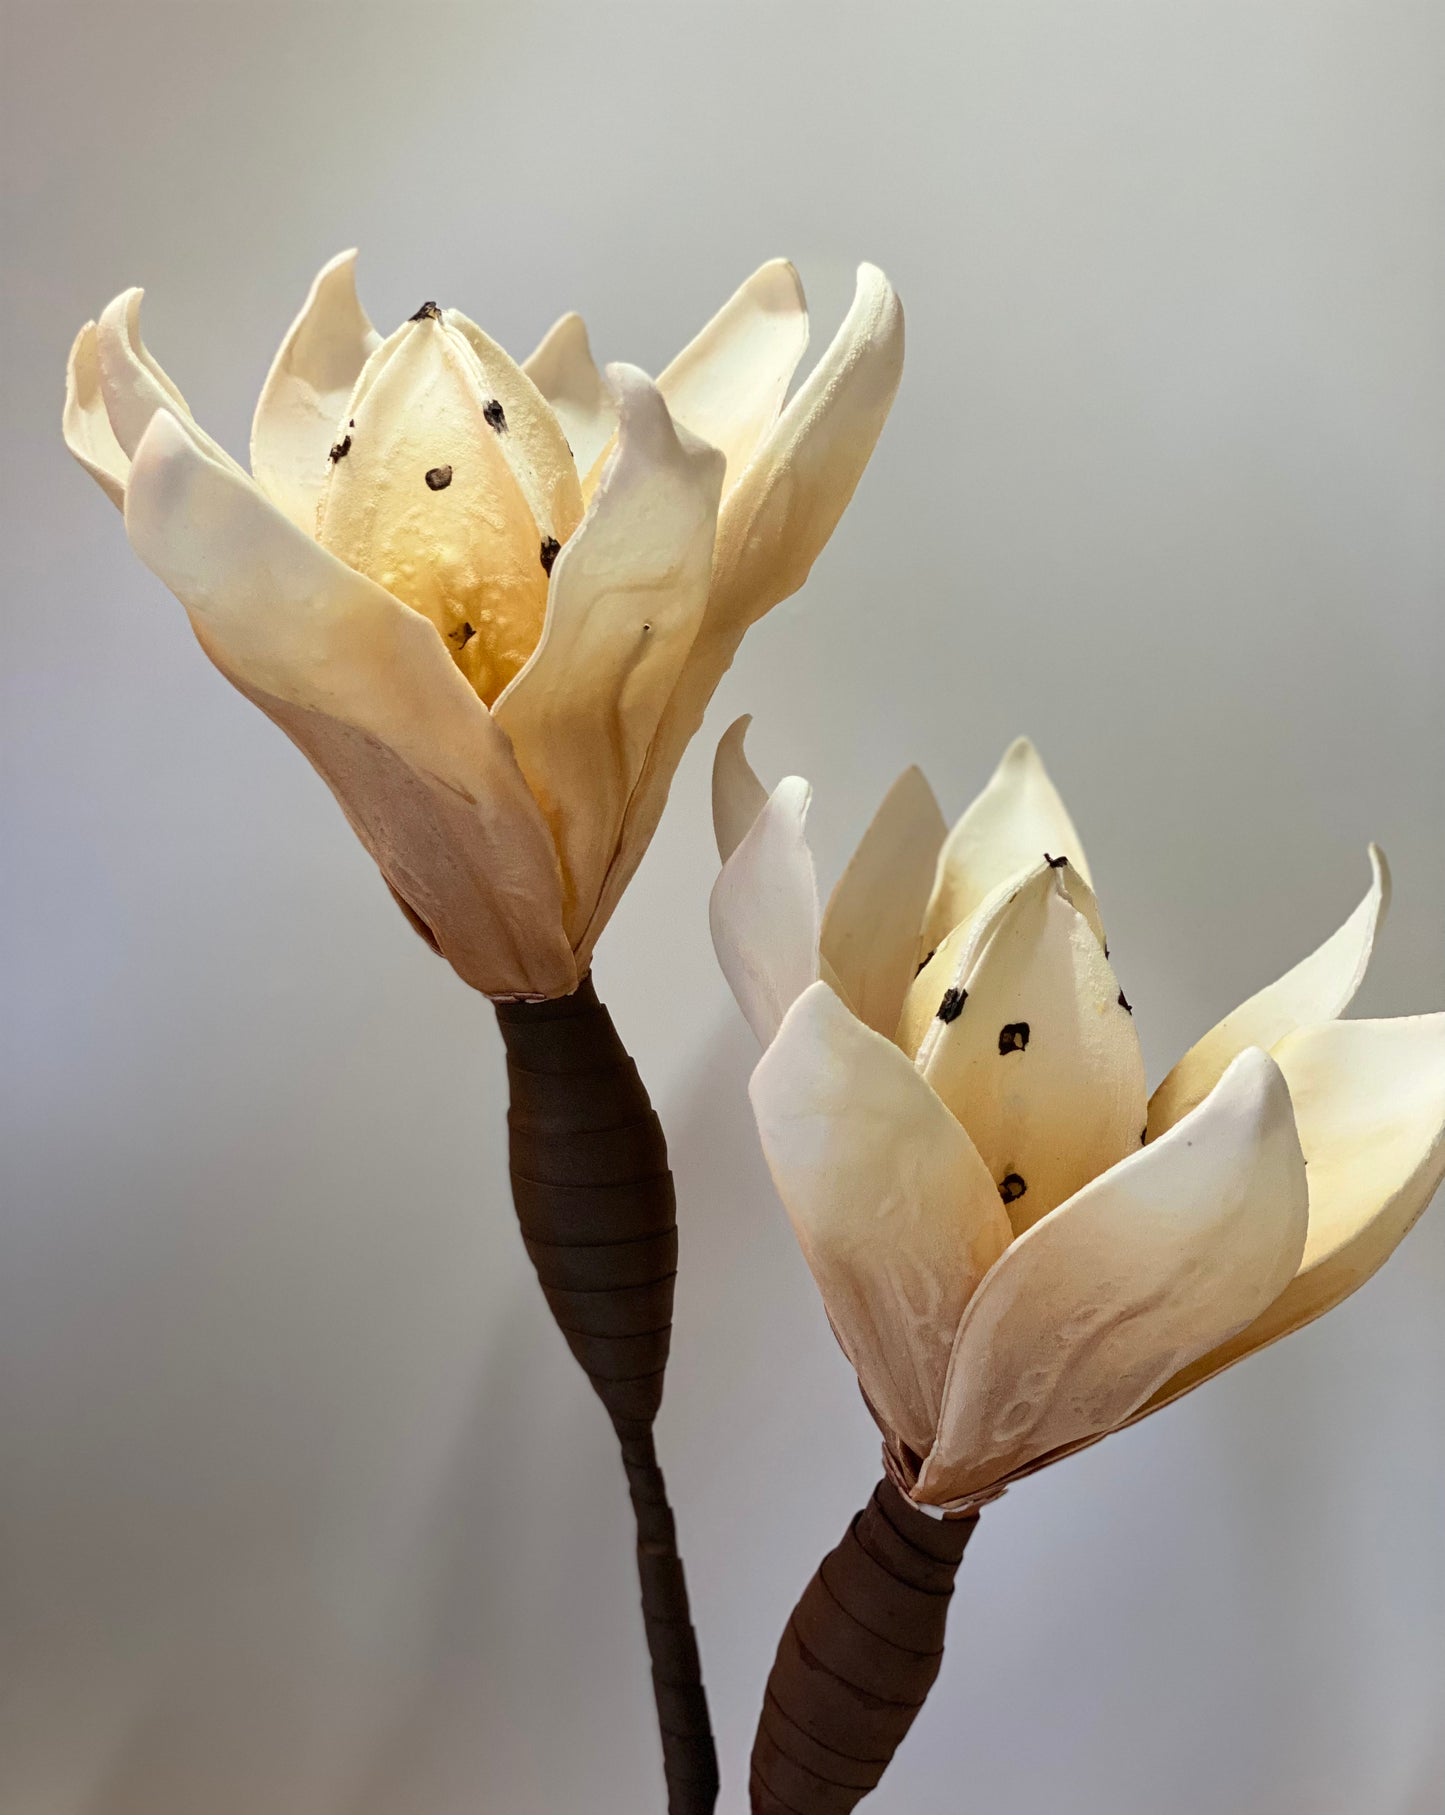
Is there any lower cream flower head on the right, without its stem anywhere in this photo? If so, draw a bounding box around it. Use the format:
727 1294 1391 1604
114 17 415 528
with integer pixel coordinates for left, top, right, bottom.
712 719 1445 1510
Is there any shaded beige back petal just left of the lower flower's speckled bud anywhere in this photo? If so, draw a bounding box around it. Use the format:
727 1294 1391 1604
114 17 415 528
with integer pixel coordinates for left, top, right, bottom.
822 768 948 1040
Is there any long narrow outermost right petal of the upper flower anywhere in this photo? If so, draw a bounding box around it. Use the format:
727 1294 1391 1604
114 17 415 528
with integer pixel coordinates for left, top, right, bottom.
577 265 904 951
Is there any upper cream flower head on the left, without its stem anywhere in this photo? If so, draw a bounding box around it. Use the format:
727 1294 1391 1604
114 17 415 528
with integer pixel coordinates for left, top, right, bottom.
64 252 902 998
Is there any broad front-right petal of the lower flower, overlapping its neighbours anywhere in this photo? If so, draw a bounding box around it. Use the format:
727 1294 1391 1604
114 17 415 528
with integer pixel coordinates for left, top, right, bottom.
919 1049 1307 1505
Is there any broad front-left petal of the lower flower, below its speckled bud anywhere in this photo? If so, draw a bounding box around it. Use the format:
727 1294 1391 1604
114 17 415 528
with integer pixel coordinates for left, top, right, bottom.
750 984 1009 1452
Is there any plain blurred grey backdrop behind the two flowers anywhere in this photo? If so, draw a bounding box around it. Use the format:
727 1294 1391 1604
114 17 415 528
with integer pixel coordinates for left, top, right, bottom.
0 0 1445 1815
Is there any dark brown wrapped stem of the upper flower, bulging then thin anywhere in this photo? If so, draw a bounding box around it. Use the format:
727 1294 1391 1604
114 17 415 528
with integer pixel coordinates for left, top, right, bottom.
497 976 717 1815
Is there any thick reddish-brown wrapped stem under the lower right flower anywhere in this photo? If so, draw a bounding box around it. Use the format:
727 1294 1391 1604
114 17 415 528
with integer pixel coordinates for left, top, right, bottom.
752 1481 978 1815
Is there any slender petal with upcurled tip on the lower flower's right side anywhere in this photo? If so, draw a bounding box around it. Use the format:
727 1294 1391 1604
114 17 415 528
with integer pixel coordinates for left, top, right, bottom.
1149 844 1391 1140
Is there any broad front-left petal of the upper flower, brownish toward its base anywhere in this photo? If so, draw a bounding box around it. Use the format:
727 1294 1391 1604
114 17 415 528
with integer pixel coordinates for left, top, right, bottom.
125 412 577 995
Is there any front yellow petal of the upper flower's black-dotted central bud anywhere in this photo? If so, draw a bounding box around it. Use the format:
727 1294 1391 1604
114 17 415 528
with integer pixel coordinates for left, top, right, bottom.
318 305 555 706
